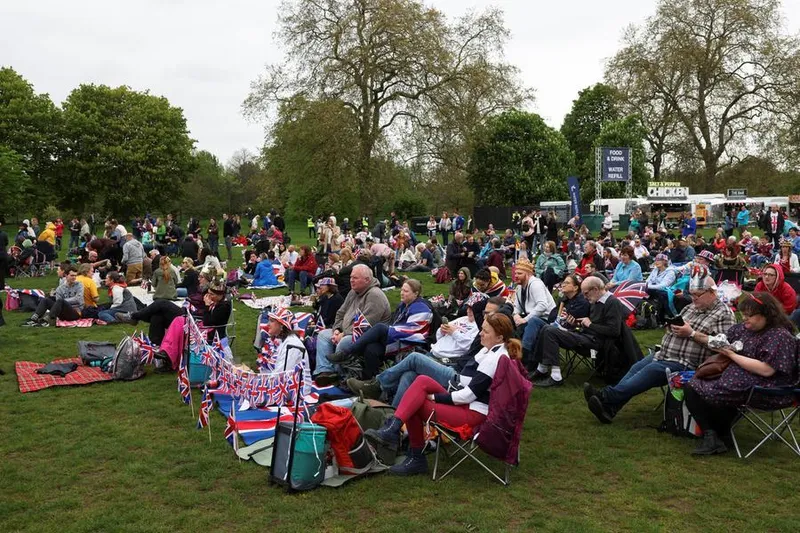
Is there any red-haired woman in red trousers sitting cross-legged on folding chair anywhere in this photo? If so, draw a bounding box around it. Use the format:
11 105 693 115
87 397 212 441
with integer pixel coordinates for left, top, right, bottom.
364 313 522 475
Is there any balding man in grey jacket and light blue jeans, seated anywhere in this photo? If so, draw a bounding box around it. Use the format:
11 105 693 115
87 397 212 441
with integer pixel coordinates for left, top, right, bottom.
314 265 392 386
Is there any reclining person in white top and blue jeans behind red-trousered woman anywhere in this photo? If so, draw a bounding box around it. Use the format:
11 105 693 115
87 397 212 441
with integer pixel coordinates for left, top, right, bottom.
347 292 490 407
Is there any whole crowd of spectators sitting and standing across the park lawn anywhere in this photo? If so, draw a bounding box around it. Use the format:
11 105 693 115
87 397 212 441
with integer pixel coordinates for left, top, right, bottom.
0 203 800 474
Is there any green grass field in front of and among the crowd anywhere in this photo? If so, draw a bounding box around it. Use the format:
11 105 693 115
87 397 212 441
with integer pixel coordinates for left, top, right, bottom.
0 222 800 532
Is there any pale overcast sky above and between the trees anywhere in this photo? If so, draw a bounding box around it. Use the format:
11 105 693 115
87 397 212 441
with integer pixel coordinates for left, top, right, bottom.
0 0 800 162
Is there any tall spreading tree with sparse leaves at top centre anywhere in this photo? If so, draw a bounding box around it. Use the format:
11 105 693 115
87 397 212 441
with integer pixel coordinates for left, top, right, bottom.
244 0 524 210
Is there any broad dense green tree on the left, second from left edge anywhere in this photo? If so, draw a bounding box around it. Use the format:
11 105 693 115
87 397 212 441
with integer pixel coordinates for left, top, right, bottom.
59 85 194 216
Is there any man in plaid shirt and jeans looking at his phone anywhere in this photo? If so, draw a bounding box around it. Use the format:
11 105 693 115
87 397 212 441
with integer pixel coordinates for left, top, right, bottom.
583 267 736 424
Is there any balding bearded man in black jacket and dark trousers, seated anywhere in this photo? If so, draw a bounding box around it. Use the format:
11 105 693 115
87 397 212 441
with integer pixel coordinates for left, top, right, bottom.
533 276 626 388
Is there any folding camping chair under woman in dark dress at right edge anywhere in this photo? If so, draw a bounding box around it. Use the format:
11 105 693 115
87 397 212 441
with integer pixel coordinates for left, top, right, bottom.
731 387 800 459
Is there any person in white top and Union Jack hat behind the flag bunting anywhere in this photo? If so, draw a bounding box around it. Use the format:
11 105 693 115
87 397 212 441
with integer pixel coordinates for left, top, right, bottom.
259 307 311 396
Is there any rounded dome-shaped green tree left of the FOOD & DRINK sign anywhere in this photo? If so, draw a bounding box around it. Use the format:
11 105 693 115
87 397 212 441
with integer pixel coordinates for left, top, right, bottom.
468 110 575 205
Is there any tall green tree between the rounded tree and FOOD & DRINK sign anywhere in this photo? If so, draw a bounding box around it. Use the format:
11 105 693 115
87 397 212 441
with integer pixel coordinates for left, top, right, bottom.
561 83 620 178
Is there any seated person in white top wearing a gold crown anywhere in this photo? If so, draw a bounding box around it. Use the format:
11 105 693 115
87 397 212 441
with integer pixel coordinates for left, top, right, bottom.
513 261 556 368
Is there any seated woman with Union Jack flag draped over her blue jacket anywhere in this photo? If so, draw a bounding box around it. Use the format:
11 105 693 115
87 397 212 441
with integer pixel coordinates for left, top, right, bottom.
328 279 433 378
